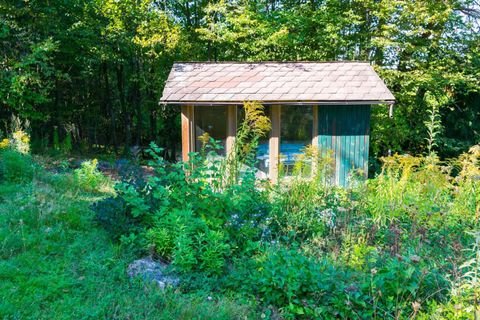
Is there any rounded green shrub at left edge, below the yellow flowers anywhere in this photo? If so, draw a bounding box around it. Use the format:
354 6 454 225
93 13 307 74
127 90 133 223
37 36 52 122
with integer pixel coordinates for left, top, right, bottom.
0 149 35 183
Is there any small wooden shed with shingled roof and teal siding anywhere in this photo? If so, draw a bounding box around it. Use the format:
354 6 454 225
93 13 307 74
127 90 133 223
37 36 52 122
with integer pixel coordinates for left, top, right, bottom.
160 62 395 185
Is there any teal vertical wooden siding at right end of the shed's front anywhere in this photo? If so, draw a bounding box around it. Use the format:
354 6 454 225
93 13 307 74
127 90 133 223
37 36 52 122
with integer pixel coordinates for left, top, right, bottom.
318 105 370 186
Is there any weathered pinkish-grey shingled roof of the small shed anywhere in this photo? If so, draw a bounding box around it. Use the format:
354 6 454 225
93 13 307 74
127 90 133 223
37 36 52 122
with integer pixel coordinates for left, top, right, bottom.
160 62 395 105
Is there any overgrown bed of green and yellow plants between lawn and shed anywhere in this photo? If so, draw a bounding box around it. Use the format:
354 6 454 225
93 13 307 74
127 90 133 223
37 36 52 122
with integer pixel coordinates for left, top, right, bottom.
101 119 480 319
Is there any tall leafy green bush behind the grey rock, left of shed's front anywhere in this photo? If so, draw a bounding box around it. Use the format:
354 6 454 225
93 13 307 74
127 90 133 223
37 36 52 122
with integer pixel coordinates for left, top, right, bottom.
116 141 262 274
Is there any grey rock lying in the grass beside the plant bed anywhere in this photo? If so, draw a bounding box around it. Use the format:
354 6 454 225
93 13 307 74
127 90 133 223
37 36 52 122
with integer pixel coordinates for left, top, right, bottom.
127 257 180 290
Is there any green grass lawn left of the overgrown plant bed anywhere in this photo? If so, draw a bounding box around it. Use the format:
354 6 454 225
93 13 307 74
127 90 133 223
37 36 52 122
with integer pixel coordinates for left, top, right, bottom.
0 162 255 319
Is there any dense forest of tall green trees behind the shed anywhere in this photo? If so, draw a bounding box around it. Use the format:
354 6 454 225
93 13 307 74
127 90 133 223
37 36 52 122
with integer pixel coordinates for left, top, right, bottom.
0 0 480 157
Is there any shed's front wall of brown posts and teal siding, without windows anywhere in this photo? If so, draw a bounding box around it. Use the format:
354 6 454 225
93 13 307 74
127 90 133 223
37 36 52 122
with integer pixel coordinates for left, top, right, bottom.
182 105 371 186
